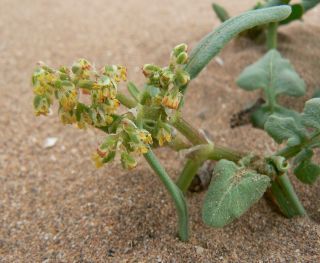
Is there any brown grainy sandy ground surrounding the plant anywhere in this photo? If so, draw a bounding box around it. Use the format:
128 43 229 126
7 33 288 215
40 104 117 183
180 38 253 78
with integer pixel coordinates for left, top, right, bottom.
0 0 320 262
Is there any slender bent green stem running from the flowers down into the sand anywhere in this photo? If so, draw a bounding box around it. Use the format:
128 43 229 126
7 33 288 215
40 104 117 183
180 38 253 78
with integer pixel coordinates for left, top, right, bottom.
144 150 189 241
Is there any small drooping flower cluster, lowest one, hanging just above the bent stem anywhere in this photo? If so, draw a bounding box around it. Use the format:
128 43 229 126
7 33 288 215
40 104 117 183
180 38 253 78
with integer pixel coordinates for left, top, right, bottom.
92 118 152 169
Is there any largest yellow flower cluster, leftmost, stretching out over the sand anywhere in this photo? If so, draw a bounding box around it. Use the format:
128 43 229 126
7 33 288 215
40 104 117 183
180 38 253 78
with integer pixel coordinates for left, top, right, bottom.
32 59 126 128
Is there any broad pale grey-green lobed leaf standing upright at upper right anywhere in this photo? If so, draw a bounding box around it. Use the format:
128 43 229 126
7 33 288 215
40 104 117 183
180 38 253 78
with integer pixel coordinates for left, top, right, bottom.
237 49 306 104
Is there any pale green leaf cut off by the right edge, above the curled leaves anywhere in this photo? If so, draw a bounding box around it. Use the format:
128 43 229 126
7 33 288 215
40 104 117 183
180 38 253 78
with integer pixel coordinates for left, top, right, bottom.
302 98 320 131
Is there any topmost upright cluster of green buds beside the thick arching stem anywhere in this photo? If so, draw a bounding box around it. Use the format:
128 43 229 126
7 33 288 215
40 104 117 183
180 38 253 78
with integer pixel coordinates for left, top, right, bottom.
143 44 190 109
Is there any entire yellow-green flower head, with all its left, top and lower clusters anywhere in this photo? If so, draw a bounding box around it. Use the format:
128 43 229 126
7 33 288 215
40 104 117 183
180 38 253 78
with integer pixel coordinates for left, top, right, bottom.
32 44 190 169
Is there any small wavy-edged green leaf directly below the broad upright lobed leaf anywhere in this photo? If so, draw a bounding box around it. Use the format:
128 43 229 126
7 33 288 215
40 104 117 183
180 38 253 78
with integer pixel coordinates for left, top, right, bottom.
264 115 307 146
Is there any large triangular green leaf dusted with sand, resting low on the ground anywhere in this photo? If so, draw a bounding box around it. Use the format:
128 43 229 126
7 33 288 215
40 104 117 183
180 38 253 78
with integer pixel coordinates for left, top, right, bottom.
202 160 270 227
